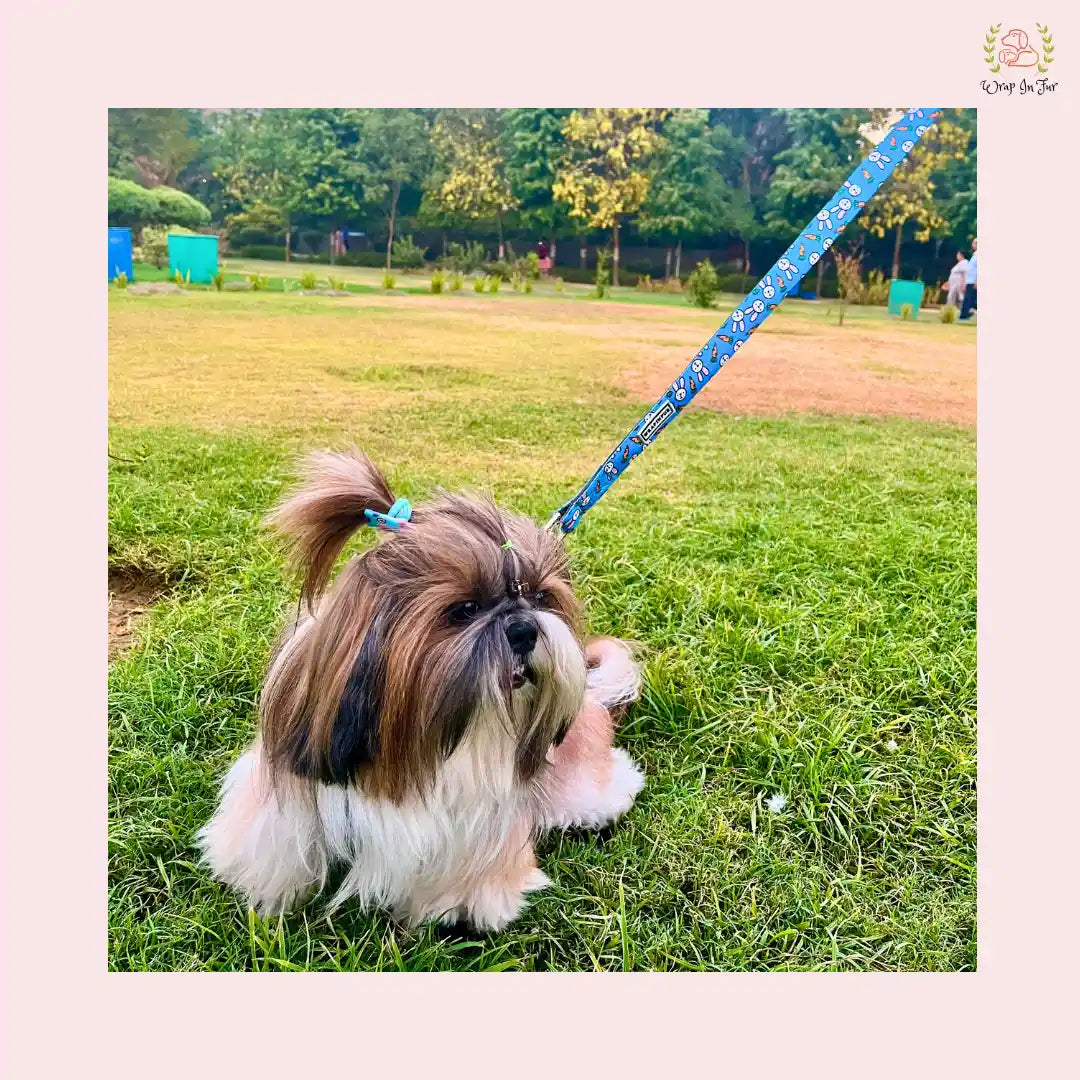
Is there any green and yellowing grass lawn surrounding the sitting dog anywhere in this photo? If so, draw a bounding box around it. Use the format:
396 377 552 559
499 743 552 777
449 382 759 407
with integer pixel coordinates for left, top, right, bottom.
109 278 976 971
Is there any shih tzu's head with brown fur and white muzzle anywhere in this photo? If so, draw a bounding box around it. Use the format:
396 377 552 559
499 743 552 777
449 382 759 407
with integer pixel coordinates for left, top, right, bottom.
262 453 585 800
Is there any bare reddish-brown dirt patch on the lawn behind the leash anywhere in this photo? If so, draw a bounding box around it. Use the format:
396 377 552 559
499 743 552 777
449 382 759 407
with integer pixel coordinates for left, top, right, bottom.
620 319 975 427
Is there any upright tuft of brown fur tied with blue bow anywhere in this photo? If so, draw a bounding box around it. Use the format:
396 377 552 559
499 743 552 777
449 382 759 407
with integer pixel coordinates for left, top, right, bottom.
265 448 394 606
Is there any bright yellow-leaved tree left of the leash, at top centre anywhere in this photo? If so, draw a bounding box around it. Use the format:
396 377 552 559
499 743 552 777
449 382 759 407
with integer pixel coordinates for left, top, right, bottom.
552 109 667 285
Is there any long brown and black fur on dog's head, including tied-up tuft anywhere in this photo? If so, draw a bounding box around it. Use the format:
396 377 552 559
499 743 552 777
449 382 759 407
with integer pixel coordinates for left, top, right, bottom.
260 450 581 801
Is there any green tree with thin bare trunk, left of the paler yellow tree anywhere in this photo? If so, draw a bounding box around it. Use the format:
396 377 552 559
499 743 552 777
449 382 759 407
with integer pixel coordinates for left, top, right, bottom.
360 109 431 270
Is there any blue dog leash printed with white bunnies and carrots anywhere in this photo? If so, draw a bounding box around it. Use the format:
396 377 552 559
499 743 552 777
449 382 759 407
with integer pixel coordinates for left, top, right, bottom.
548 109 941 532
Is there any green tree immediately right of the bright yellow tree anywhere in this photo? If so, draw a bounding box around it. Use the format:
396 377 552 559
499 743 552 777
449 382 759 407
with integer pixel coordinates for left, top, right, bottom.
637 109 746 278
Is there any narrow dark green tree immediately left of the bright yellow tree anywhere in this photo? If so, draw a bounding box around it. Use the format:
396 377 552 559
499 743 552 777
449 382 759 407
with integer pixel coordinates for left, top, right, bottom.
503 109 570 261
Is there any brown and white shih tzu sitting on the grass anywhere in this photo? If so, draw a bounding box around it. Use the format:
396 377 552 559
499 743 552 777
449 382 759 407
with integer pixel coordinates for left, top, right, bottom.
199 451 643 930
